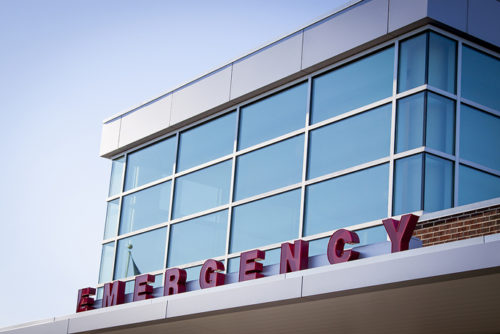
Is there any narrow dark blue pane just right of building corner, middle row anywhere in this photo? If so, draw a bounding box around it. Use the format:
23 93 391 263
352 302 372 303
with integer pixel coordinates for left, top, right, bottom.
425 92 455 154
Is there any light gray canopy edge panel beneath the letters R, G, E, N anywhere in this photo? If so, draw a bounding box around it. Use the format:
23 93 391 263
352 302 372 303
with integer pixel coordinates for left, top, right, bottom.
167 275 302 318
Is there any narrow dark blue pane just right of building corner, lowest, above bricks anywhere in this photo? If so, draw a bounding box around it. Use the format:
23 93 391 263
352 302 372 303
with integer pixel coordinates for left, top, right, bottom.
424 154 454 212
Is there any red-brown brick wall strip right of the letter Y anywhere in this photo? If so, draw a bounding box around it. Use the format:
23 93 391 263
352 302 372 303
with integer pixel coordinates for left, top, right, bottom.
413 205 500 247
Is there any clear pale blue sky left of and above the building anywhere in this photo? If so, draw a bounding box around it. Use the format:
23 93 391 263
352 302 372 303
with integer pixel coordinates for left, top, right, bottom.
0 0 347 328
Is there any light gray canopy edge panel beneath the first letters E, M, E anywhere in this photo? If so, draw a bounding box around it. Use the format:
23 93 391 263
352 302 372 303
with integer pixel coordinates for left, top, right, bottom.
68 298 167 333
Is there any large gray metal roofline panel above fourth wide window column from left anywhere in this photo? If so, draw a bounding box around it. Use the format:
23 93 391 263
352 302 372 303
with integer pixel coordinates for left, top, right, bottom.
302 0 392 69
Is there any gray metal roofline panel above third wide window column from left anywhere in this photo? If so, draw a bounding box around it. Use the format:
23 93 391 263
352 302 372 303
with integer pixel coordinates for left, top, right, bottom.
231 32 302 99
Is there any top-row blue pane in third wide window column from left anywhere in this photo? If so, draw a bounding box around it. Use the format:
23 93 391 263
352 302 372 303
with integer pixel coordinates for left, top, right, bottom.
238 83 307 149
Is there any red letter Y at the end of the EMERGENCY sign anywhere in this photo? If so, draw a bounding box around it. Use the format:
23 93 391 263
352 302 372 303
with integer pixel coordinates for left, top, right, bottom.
383 215 418 253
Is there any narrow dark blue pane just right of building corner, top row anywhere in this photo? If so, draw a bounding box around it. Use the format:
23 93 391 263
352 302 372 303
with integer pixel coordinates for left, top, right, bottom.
429 32 457 93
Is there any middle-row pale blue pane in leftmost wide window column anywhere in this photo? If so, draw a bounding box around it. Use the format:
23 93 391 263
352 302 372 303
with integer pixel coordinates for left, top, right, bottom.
120 181 171 234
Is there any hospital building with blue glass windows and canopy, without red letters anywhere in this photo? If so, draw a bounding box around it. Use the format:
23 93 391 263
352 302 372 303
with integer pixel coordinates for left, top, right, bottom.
3 0 500 333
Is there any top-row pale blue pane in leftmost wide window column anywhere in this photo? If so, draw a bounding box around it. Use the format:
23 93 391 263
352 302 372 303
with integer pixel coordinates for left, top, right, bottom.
125 137 176 190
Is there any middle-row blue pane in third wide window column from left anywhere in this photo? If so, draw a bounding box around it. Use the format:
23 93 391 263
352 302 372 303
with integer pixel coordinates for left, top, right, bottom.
234 135 304 200
